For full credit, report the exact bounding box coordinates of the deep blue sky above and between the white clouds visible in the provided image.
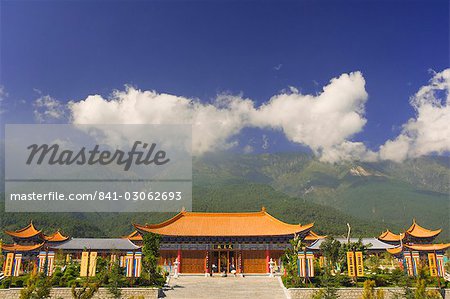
[0,0,449,158]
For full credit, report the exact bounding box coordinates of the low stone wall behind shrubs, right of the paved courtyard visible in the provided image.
[288,288,450,299]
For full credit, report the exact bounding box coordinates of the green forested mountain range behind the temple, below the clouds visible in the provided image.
[0,153,450,240]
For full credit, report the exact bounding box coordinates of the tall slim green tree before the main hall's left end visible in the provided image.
[142,233,165,286]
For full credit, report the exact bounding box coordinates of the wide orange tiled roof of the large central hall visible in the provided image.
[134,208,314,236]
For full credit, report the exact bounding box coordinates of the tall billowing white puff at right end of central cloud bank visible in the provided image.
[254,72,368,162]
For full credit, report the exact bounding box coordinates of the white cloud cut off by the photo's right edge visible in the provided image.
[379,69,450,162]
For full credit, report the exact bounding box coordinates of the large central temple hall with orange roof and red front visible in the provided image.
[134,207,313,274]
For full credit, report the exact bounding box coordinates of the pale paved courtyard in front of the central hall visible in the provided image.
[163,276,286,299]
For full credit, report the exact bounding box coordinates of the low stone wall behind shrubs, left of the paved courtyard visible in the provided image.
[0,288,159,299]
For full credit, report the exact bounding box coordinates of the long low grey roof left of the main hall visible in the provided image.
[51,238,141,250]
